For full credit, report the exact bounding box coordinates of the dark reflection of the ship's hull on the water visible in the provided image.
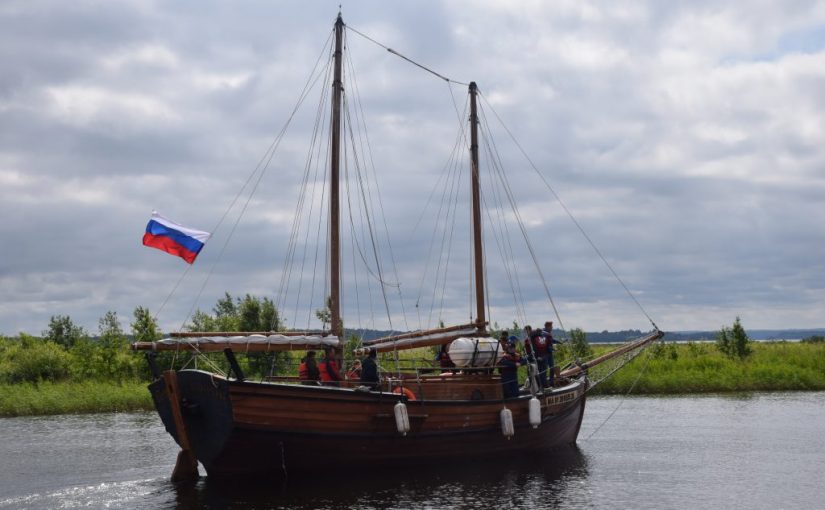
[174,447,587,509]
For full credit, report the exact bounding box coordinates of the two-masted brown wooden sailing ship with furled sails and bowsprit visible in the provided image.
[133,15,662,479]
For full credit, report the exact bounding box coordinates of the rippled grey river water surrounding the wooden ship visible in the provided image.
[0,392,825,510]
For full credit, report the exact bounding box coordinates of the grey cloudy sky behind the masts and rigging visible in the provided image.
[0,0,825,335]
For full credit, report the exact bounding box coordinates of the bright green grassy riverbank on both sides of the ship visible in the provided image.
[0,342,825,417]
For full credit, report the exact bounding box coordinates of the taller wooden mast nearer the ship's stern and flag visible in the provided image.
[329,12,344,338]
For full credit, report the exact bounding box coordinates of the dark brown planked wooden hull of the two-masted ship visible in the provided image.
[150,370,586,477]
